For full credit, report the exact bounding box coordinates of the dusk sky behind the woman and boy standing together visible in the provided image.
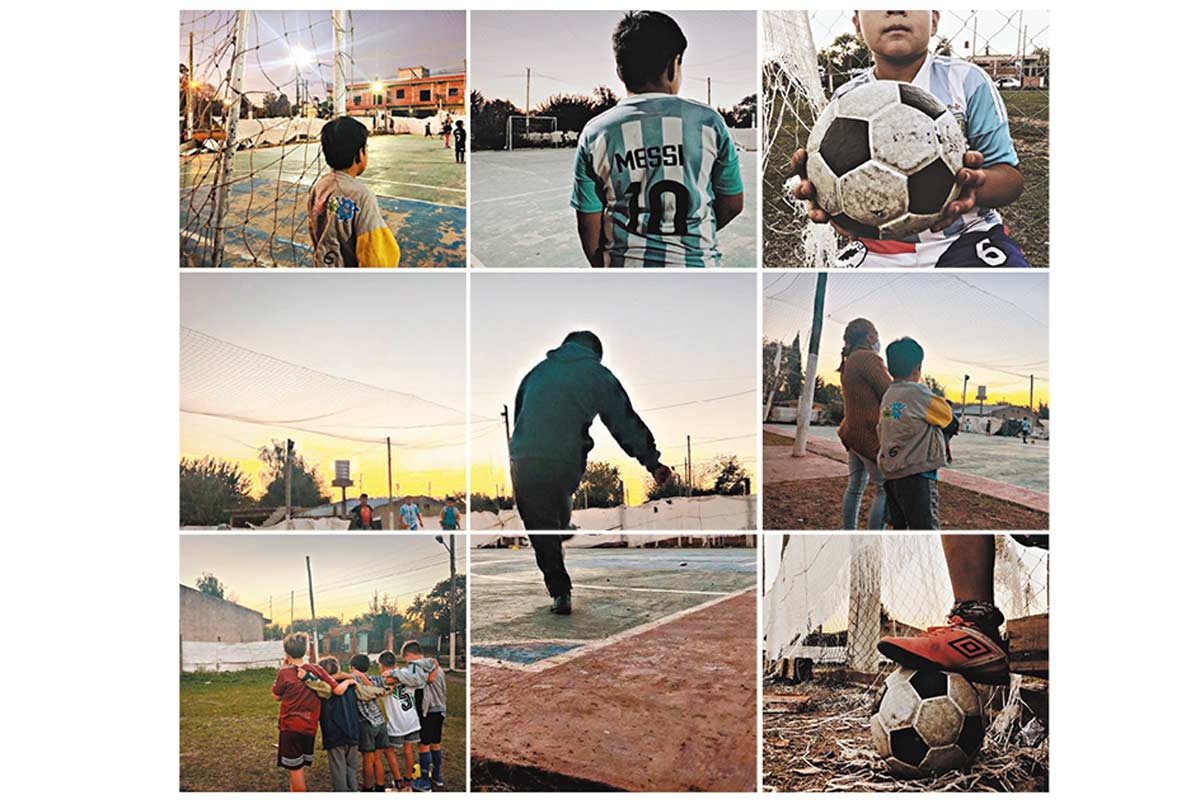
[763,271,1050,405]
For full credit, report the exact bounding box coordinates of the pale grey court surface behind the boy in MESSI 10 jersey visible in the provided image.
[470,148,758,269]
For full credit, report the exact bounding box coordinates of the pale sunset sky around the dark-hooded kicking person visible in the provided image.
[470,271,758,504]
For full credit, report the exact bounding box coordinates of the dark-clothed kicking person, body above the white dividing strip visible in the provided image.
[509,331,671,544]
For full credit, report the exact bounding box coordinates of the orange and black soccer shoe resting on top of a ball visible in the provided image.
[878,603,1008,686]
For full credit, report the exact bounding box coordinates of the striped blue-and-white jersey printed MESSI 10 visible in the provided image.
[571,94,742,267]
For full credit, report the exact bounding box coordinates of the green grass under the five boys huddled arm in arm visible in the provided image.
[179,669,467,792]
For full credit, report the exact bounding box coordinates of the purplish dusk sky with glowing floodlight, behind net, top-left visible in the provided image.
[179,11,467,100]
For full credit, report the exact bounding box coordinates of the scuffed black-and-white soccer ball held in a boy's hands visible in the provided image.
[808,80,967,239]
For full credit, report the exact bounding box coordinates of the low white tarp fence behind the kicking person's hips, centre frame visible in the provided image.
[470,494,758,530]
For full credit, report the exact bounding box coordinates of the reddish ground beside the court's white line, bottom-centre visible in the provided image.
[470,591,757,792]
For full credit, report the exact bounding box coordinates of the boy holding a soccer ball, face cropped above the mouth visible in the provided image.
[792,11,1028,267]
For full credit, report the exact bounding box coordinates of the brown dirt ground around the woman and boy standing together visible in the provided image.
[762,479,1050,530]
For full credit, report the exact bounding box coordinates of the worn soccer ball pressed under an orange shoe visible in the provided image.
[871,669,983,777]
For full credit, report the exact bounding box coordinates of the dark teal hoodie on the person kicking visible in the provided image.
[509,342,659,477]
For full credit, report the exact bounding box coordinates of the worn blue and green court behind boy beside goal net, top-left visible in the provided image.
[179,136,467,267]
